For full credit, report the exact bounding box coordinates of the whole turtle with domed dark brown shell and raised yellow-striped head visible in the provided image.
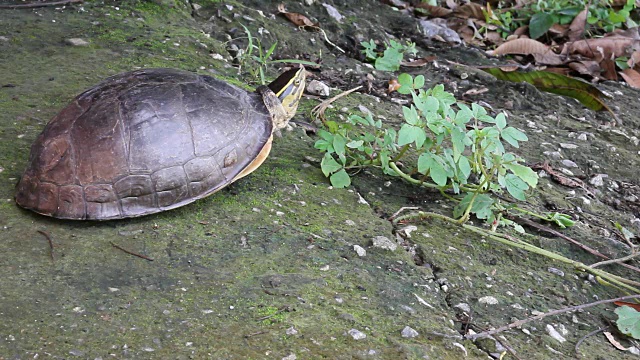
[15,66,306,220]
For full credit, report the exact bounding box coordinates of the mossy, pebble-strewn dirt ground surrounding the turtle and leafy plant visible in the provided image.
[0,0,640,359]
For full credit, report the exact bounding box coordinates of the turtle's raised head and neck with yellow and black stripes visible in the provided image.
[267,65,307,129]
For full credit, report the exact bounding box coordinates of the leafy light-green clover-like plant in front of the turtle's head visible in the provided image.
[315,74,538,222]
